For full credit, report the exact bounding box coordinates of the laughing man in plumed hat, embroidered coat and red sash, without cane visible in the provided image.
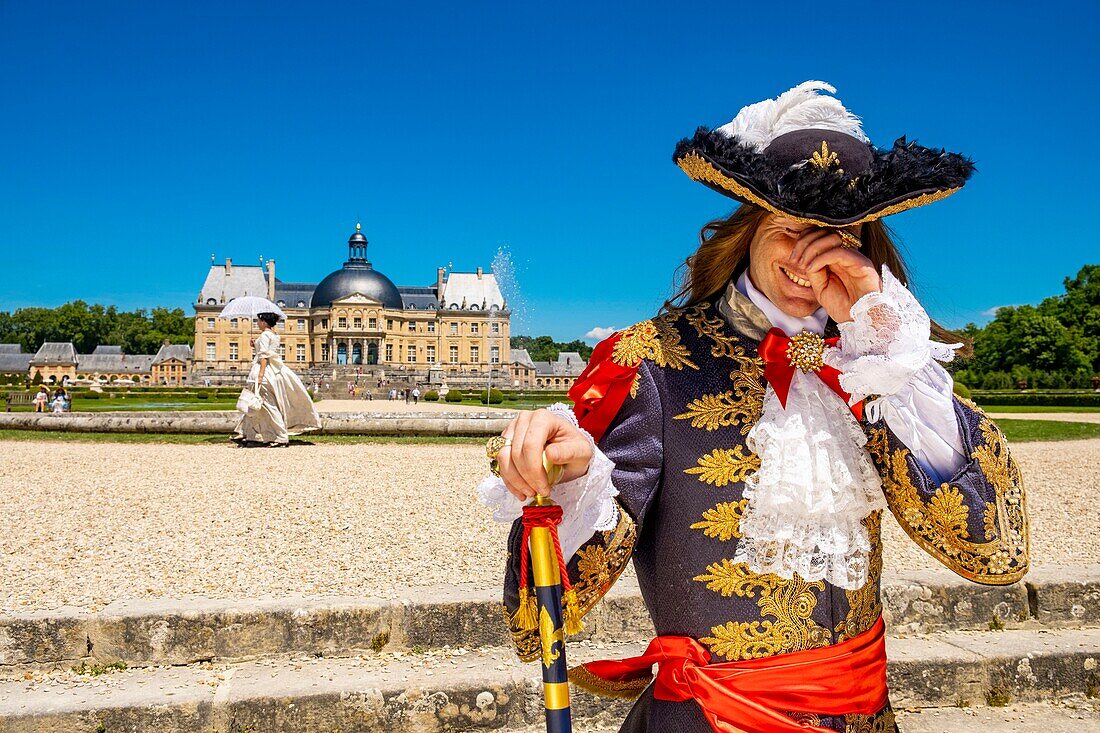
[479,81,1029,733]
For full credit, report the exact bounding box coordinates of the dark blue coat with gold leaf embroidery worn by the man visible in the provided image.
[504,294,1029,733]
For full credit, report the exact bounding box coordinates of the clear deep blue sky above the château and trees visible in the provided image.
[0,0,1100,340]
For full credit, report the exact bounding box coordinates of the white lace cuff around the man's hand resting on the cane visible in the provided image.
[477,402,619,558]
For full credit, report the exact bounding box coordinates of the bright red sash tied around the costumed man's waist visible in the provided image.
[582,616,887,733]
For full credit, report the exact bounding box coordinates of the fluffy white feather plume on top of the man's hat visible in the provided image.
[716,81,869,153]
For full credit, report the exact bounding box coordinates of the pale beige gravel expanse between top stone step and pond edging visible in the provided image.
[0,440,1100,613]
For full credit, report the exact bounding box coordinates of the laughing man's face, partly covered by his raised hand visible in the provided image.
[749,214,858,318]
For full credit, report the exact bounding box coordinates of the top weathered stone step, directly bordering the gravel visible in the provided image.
[0,566,1100,669]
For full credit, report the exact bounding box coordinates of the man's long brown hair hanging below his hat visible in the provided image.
[661,204,970,357]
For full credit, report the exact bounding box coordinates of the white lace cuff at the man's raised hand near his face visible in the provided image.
[825,265,963,407]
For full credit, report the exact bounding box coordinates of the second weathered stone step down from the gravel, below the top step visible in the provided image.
[0,630,1100,733]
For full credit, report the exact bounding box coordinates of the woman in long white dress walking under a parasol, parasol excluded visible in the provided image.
[233,313,321,448]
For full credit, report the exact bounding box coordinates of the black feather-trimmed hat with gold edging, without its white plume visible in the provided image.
[672,128,975,227]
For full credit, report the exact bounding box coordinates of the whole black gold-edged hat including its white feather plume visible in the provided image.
[672,81,974,228]
